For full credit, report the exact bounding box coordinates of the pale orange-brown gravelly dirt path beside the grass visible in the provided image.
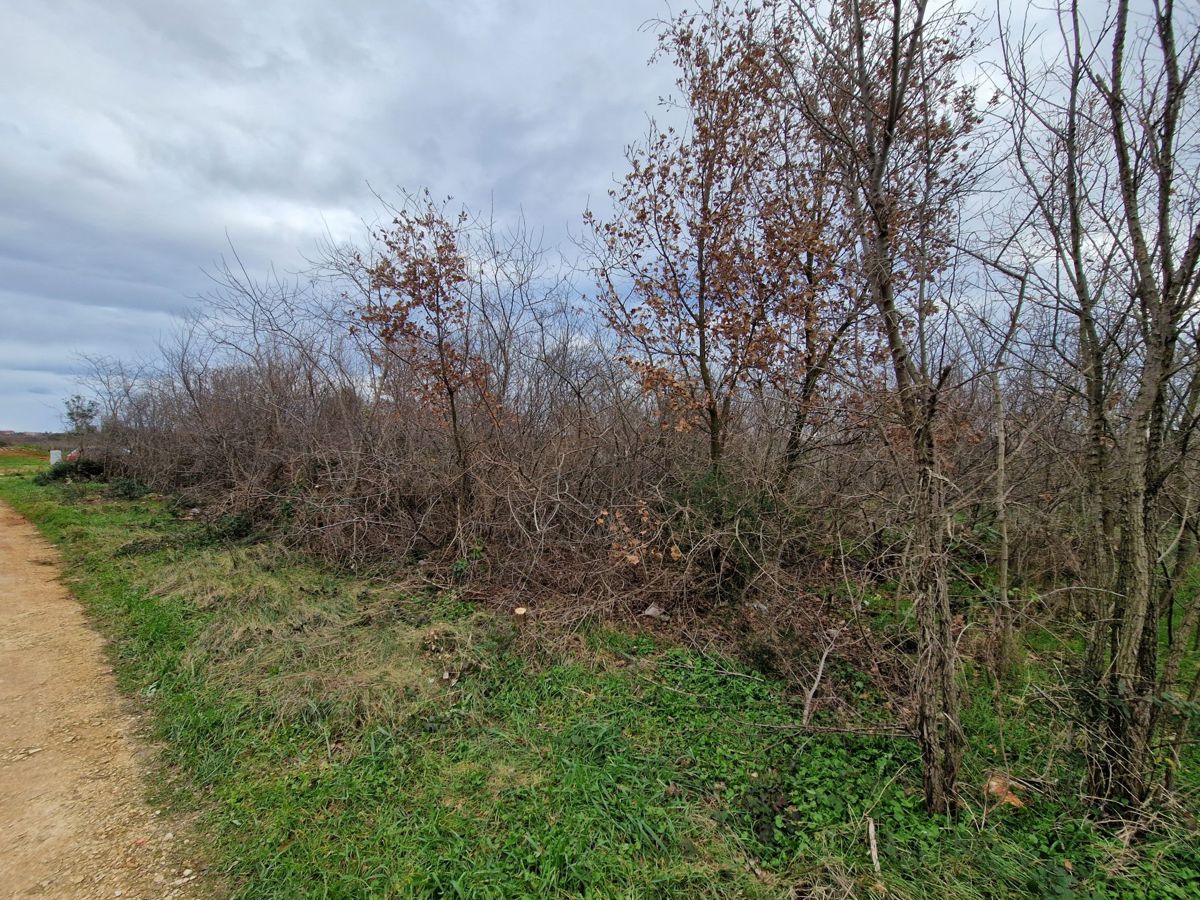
[0,505,206,898]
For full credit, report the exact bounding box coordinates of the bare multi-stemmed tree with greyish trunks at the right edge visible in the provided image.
[1004,0,1200,804]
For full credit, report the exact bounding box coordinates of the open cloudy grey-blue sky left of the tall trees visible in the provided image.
[0,0,673,431]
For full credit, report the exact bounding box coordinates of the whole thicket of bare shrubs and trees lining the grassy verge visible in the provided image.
[87,0,1200,814]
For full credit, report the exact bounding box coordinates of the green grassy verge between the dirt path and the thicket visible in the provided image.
[0,476,1200,898]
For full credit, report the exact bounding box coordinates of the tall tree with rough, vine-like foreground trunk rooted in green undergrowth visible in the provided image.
[770,0,979,812]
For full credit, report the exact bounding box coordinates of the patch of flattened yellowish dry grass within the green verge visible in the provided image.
[146,545,494,733]
